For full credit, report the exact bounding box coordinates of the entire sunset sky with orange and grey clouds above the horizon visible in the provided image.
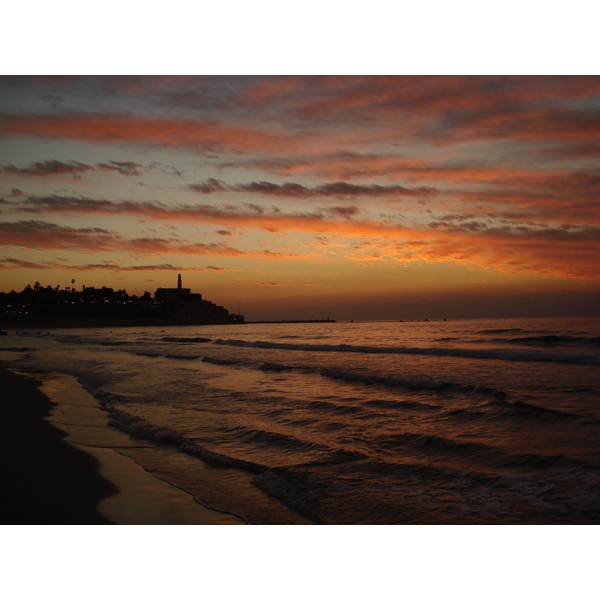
[0,75,600,320]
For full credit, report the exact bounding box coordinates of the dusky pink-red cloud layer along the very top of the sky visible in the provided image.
[0,76,600,158]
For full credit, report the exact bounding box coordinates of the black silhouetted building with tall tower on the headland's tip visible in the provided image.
[154,275,244,325]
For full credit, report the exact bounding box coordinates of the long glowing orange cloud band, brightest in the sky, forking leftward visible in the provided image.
[0,198,600,277]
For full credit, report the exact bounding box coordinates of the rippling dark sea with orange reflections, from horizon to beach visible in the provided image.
[0,318,600,525]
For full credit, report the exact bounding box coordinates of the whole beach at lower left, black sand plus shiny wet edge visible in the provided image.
[0,363,244,525]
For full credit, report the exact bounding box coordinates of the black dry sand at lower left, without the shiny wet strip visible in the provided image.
[0,368,118,525]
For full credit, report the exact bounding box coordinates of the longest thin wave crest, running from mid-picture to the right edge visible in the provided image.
[213,338,600,365]
